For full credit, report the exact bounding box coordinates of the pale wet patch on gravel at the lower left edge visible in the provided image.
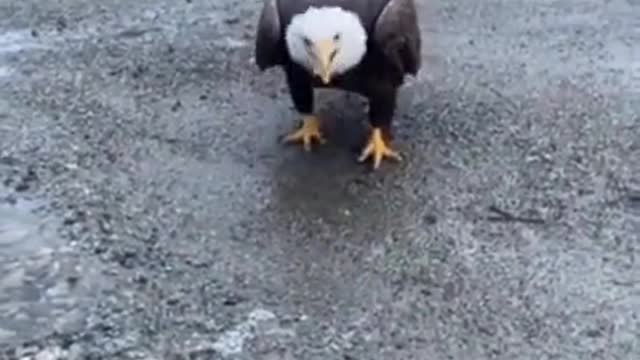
[0,187,108,345]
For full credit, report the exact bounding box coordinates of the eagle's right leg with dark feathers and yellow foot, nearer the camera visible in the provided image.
[358,88,402,169]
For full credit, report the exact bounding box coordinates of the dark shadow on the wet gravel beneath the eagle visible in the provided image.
[272,90,371,217]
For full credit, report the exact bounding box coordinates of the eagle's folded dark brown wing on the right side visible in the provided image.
[373,0,421,75]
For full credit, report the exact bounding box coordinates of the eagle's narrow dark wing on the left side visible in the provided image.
[255,0,284,70]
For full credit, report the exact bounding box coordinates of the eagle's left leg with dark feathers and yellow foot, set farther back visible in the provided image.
[283,66,326,151]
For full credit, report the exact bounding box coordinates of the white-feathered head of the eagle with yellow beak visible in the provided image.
[286,7,367,84]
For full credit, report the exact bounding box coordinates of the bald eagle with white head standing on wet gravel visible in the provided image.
[255,0,421,169]
